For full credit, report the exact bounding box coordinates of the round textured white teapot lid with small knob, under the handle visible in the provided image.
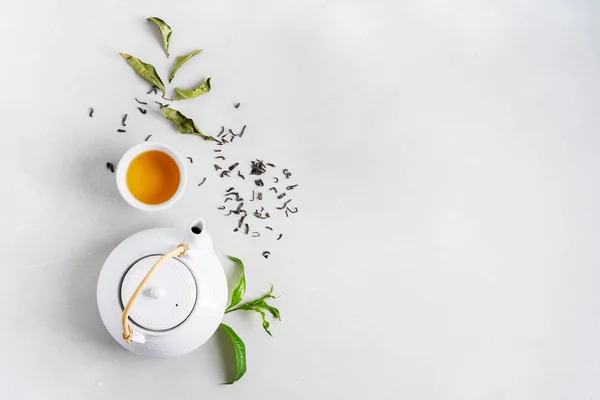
[120,255,197,331]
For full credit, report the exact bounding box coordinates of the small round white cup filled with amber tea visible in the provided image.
[116,142,187,211]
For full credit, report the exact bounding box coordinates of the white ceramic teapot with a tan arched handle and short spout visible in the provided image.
[97,218,227,357]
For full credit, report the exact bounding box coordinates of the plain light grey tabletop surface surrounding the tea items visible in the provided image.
[0,0,600,400]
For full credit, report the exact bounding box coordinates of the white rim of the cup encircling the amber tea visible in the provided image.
[115,142,187,211]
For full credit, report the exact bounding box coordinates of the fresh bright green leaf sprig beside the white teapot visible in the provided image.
[221,256,281,384]
